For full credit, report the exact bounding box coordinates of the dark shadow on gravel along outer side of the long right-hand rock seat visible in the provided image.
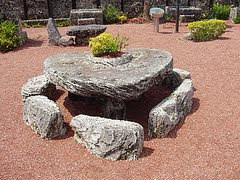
[166,98,200,138]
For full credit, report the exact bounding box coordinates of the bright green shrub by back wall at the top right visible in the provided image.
[211,3,231,20]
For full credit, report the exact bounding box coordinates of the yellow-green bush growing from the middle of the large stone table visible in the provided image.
[89,33,128,56]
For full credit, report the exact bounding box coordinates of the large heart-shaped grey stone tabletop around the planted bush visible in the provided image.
[44,49,173,100]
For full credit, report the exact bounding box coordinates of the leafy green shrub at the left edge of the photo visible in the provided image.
[0,21,24,52]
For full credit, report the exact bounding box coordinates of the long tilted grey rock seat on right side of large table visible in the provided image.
[148,79,194,138]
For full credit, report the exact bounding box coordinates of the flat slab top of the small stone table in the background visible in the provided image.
[67,24,107,37]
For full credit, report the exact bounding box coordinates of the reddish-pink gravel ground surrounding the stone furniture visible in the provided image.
[0,23,240,179]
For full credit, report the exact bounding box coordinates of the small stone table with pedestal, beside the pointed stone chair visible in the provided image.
[67,24,107,46]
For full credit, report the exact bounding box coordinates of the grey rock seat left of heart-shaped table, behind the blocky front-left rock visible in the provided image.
[21,75,56,102]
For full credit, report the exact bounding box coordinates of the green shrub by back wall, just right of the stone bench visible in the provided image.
[103,5,122,24]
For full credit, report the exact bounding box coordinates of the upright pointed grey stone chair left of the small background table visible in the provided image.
[47,18,74,46]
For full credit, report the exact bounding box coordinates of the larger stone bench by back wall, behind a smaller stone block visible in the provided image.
[70,9,103,25]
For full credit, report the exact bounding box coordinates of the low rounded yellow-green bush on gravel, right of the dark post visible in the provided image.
[188,20,226,41]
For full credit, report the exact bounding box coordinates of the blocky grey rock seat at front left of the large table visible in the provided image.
[24,96,66,139]
